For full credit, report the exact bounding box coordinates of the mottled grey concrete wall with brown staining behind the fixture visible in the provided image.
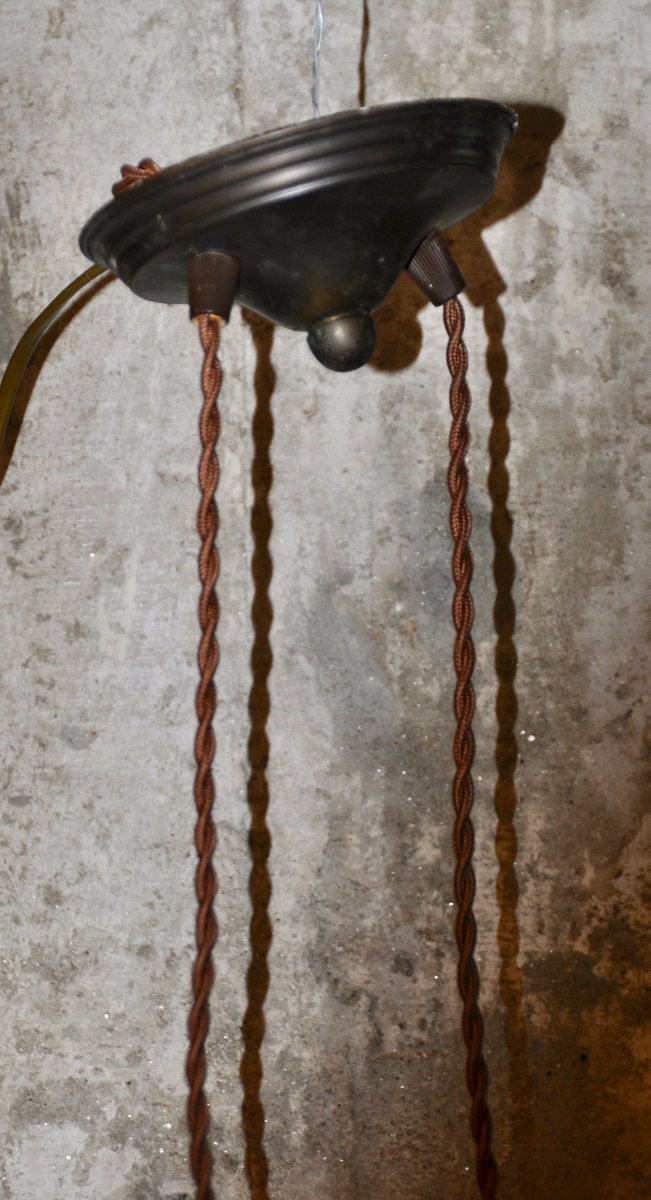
[0,0,651,1200]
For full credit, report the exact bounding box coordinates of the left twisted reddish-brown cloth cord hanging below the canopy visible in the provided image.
[185,316,228,1200]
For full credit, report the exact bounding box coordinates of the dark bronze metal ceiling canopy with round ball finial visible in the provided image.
[79,100,516,370]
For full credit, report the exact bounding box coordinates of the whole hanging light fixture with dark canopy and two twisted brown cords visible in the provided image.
[0,0,516,1200]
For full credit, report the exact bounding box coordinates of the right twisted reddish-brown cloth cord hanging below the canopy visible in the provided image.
[443,292,497,1200]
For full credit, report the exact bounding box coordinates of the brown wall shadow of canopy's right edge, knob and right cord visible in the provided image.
[371,101,565,1200]
